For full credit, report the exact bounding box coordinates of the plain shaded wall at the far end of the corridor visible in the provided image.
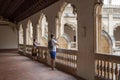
[0,25,18,49]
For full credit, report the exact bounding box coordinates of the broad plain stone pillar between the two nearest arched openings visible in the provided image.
[77,0,95,80]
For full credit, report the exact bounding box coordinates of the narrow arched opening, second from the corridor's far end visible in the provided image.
[26,20,33,45]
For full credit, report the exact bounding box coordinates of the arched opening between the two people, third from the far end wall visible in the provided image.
[37,14,48,46]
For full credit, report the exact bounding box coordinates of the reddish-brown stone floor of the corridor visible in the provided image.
[0,53,77,80]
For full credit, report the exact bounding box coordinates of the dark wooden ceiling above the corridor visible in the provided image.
[0,0,58,22]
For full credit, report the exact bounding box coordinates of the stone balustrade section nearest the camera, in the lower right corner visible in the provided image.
[95,53,120,80]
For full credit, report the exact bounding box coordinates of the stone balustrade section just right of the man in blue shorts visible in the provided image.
[56,49,77,74]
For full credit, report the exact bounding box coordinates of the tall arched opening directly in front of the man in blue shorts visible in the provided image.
[56,3,78,50]
